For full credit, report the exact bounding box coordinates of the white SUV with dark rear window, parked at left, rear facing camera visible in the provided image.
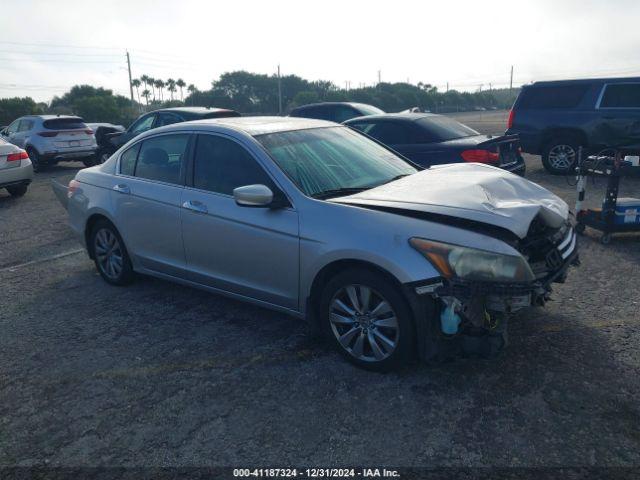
[0,115,98,171]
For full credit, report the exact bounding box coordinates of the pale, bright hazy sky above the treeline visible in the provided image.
[0,0,640,101]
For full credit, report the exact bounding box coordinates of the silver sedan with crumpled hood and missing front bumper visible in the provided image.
[54,117,577,369]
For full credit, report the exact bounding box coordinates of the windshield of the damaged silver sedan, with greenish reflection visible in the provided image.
[256,127,417,198]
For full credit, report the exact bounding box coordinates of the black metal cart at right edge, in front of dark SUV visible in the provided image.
[575,152,640,245]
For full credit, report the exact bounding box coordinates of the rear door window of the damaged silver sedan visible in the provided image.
[134,134,189,184]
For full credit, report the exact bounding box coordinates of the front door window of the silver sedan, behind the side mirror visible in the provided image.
[193,135,274,195]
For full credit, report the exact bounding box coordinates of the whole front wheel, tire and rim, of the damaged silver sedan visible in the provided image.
[319,268,415,371]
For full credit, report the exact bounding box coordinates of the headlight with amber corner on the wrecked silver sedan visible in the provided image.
[409,237,535,282]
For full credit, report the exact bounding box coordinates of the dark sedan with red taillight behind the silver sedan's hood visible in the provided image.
[344,113,525,175]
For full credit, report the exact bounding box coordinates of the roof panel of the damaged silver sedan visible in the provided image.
[142,116,340,137]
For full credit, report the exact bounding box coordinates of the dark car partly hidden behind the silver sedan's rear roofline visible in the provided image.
[96,107,240,163]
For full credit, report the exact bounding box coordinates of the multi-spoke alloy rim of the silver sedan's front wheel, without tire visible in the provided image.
[329,285,400,362]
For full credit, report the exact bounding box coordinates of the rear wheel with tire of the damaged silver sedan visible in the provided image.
[90,220,134,286]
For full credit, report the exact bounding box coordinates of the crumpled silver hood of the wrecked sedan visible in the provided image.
[331,163,569,238]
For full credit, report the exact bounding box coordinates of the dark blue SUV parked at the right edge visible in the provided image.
[506,77,640,174]
